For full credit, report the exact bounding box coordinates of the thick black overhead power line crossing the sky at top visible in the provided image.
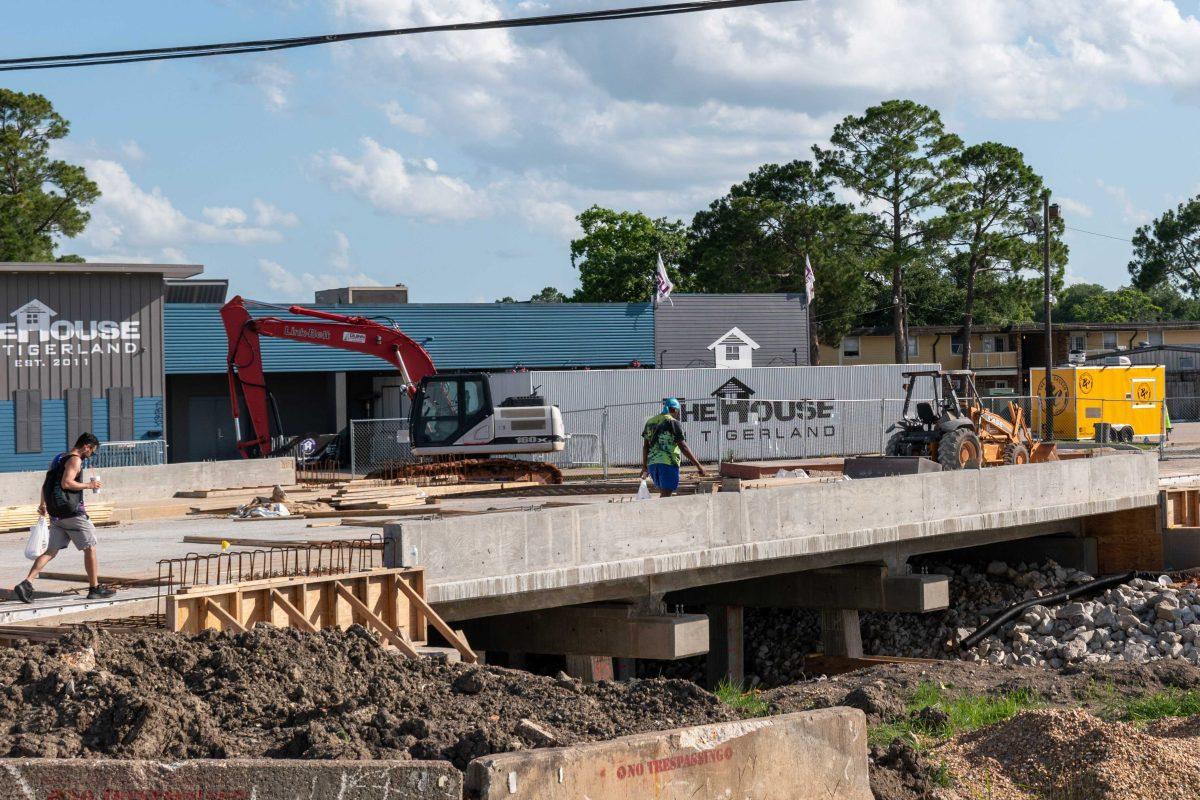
[0,0,799,72]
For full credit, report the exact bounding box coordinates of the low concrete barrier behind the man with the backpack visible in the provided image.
[0,458,296,505]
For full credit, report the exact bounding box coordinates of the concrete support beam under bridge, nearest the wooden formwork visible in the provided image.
[456,604,708,673]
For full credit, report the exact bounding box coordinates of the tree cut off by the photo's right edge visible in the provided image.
[1129,197,1200,297]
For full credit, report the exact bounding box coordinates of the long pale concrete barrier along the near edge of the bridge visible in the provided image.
[385,453,1158,619]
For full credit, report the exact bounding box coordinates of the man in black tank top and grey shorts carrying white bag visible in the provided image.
[13,433,116,603]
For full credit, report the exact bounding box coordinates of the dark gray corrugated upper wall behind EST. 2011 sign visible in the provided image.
[0,273,163,399]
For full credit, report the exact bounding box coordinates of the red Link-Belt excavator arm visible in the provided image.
[221,296,437,458]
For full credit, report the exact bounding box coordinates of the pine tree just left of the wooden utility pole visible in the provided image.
[944,142,1067,369]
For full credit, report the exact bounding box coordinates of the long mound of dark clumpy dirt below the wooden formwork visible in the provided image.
[0,626,737,769]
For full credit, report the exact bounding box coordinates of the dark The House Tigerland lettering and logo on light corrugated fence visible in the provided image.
[679,378,838,443]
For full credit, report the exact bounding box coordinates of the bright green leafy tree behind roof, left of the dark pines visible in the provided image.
[571,205,688,302]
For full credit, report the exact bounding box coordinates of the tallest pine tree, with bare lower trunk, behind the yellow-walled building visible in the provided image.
[812,100,962,363]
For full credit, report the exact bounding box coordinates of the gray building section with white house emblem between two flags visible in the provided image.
[654,294,811,369]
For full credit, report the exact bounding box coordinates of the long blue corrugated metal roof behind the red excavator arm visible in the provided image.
[163,302,654,375]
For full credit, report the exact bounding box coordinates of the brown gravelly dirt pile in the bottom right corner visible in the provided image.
[930,709,1200,800]
